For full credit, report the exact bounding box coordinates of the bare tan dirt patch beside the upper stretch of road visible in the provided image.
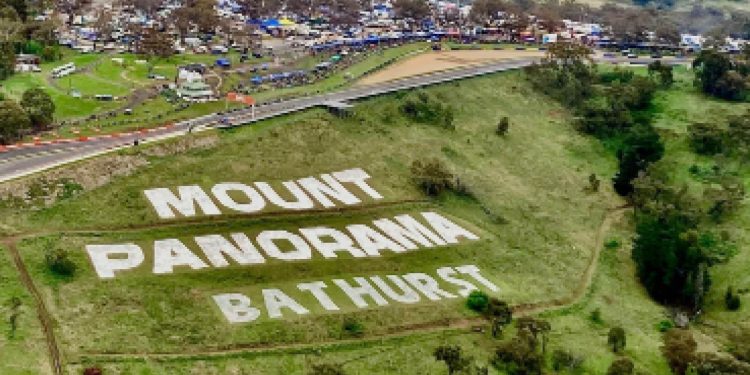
[357,50,544,85]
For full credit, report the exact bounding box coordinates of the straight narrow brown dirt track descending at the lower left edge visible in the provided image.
[2,238,63,375]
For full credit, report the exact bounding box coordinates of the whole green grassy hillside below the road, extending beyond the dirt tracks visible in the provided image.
[0,63,750,375]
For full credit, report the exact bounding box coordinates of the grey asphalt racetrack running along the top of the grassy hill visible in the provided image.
[0,57,688,182]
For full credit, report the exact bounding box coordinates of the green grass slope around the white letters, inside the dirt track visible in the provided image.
[2,72,632,373]
